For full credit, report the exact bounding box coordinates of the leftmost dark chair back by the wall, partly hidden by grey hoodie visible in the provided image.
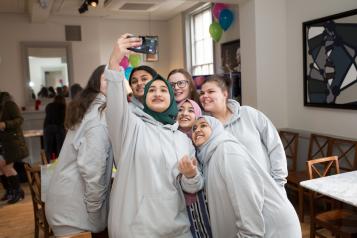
[279,130,299,171]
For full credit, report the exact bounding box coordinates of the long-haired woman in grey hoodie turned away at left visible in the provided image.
[45,65,113,237]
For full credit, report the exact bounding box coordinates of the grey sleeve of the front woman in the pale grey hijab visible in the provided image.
[219,147,265,238]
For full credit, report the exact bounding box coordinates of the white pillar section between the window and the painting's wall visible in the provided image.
[239,0,287,127]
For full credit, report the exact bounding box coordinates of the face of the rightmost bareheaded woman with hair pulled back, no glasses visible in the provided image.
[200,82,228,114]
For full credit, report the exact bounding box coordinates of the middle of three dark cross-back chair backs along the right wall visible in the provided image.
[307,134,331,160]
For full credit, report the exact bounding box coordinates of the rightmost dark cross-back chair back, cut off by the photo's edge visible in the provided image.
[329,138,357,172]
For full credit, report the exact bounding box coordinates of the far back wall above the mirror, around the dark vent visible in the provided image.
[0,14,170,106]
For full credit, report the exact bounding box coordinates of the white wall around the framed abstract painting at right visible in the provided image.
[286,0,357,138]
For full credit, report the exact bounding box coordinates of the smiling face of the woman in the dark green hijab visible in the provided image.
[146,80,170,112]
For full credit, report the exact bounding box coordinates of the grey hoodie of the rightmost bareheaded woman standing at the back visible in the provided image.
[224,99,288,187]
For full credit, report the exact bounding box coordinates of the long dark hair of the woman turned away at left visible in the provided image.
[64,65,106,130]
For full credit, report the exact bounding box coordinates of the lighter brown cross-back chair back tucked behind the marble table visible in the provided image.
[306,156,340,179]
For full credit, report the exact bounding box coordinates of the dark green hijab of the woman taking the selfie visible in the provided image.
[144,74,178,125]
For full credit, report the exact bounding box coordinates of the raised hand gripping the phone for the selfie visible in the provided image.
[109,33,142,71]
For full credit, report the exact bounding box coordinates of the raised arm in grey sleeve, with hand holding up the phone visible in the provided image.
[104,34,141,165]
